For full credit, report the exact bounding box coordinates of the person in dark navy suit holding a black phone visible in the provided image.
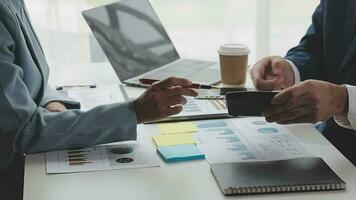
[251,0,356,165]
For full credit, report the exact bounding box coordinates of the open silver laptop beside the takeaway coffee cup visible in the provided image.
[83,0,220,86]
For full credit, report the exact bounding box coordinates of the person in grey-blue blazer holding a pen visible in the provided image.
[0,0,197,200]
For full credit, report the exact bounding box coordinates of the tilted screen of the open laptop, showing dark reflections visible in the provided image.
[83,0,179,82]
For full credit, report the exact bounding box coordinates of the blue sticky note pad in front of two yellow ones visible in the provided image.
[157,144,205,162]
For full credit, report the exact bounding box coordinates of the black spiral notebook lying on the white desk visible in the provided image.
[210,157,346,196]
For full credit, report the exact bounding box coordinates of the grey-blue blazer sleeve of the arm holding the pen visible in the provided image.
[0,18,137,162]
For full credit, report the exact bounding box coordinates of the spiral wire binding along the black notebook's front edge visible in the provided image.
[224,182,346,195]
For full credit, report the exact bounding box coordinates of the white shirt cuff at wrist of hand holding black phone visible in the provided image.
[334,85,356,130]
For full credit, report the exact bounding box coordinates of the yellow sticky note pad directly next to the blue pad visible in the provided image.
[153,134,195,147]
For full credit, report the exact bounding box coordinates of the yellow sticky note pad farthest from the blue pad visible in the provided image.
[158,122,199,134]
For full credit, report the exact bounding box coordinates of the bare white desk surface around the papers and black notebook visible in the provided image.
[24,88,356,200]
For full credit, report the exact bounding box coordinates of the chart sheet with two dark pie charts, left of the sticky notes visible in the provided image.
[46,126,159,174]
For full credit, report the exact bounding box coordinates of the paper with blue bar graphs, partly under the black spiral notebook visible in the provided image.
[196,117,309,163]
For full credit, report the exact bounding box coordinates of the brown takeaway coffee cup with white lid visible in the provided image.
[218,44,250,85]
